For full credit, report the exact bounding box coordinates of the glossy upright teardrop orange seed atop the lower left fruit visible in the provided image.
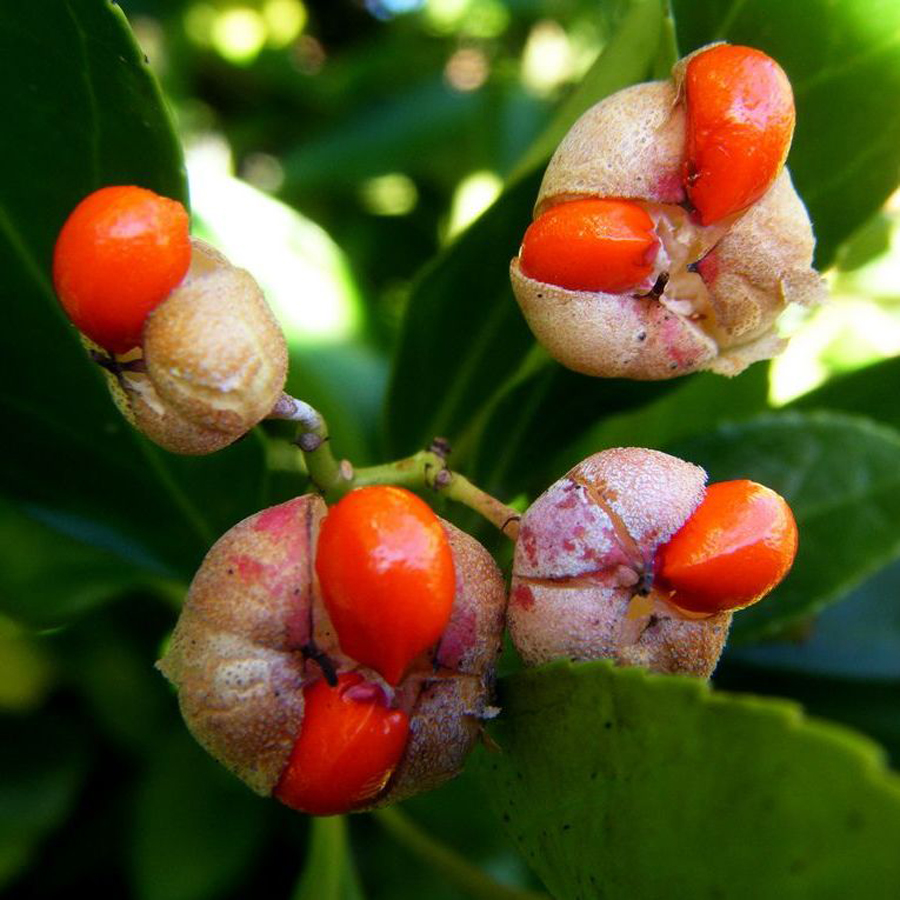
[316,485,456,684]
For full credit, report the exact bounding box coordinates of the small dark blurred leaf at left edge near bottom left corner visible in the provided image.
[0,715,87,887]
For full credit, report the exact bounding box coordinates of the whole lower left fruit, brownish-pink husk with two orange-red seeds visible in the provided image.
[159,486,506,815]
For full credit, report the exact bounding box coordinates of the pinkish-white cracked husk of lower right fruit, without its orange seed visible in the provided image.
[508,448,731,677]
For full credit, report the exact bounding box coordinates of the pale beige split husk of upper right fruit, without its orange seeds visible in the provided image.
[510,45,824,380]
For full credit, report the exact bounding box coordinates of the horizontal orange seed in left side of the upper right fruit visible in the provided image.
[521,199,659,294]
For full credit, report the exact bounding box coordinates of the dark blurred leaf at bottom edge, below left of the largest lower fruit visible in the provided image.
[132,727,267,900]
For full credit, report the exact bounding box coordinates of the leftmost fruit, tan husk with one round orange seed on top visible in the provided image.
[53,186,287,454]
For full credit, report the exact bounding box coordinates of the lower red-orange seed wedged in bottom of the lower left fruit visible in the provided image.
[273,672,409,816]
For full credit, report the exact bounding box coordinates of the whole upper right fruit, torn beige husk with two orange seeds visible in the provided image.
[510,44,823,379]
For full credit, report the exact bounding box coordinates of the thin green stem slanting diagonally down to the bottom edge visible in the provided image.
[372,807,550,900]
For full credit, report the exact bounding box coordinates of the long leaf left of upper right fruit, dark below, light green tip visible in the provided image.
[386,0,668,455]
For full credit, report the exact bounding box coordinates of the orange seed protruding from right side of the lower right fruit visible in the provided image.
[656,481,797,614]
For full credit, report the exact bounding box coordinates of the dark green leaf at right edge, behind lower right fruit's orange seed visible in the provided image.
[667,412,900,641]
